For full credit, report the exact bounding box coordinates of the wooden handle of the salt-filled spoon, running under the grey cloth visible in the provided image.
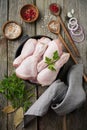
[58,34,87,82]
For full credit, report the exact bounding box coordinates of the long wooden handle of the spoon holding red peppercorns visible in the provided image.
[58,16,79,56]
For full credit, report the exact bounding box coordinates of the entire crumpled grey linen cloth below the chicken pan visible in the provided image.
[24,64,86,127]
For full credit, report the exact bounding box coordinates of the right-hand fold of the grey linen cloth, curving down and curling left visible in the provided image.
[51,64,86,115]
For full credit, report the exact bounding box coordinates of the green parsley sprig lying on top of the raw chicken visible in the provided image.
[45,51,60,71]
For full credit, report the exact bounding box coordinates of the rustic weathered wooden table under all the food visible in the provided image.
[0,0,87,130]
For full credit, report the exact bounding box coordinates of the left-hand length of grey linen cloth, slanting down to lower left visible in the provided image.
[24,80,67,127]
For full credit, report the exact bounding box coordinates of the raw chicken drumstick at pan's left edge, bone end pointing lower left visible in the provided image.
[13,39,37,67]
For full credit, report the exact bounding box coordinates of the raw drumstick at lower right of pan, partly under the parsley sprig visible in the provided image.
[37,53,70,86]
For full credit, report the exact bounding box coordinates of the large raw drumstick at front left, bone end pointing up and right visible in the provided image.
[16,42,47,80]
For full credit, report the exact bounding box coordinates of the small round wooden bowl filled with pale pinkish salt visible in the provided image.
[3,21,22,40]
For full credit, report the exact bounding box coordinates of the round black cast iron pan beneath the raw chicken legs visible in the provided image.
[15,35,72,84]
